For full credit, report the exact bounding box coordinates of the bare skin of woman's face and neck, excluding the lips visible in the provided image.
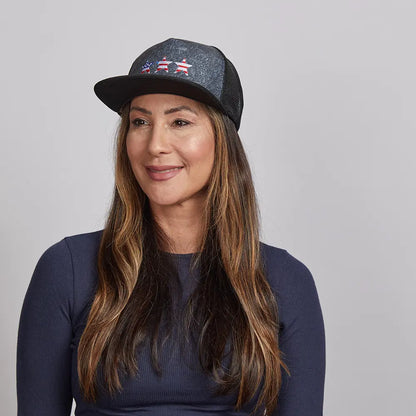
[126,94,215,253]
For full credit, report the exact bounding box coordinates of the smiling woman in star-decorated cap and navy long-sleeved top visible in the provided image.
[17,39,325,416]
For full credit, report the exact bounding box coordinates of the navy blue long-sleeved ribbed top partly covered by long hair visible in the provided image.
[17,230,325,416]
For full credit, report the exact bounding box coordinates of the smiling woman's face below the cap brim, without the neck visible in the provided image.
[126,94,215,209]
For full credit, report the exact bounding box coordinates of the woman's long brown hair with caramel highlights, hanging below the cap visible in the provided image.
[78,100,288,414]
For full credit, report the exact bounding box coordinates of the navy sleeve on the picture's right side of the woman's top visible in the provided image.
[273,252,325,416]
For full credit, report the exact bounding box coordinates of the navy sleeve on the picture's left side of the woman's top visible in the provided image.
[16,239,73,416]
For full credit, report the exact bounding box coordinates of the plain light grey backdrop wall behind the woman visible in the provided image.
[0,0,416,416]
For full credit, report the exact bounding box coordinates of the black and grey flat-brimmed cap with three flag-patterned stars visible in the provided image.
[94,38,243,130]
